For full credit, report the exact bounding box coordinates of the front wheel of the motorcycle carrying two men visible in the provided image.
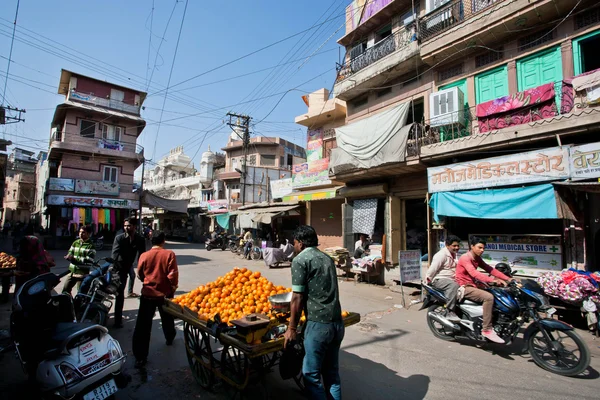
[527,328,590,376]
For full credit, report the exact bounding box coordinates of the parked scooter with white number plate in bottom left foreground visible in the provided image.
[10,271,128,400]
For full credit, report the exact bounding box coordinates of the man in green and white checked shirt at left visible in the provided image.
[63,225,96,294]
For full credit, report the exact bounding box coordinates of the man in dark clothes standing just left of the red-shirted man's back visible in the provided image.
[112,217,146,329]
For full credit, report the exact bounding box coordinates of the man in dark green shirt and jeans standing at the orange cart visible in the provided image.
[284,225,345,400]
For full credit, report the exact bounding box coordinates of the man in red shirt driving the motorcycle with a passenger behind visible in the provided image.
[454,237,512,343]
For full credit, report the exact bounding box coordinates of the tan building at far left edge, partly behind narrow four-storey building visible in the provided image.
[2,147,37,225]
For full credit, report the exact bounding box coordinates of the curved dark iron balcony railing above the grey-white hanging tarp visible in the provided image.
[337,29,417,82]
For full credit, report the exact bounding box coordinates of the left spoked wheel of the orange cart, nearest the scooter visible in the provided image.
[184,323,215,390]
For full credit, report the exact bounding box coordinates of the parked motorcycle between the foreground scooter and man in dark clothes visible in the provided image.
[73,257,121,325]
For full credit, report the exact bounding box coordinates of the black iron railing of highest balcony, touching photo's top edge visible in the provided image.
[420,0,504,41]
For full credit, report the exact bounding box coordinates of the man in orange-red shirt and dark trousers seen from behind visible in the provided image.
[133,232,179,368]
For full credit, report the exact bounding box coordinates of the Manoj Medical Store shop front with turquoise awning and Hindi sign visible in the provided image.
[427,146,585,277]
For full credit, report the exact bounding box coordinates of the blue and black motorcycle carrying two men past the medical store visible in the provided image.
[421,280,590,376]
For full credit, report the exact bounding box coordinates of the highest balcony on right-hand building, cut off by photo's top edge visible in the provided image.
[419,0,584,63]
